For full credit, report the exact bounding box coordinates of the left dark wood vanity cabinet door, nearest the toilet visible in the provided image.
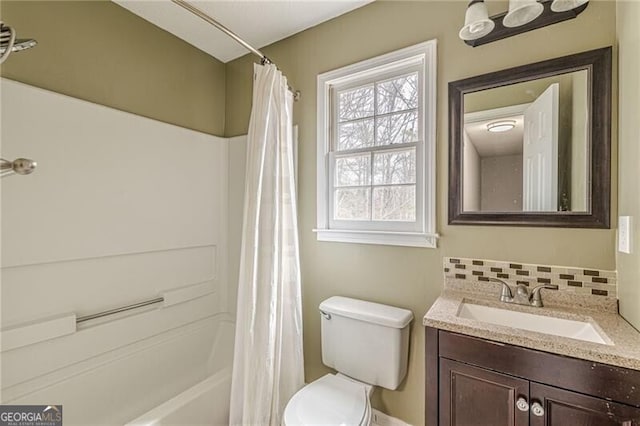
[440,358,529,426]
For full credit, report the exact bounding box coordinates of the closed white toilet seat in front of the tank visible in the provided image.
[283,374,371,426]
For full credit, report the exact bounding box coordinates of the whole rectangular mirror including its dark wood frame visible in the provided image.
[449,48,611,228]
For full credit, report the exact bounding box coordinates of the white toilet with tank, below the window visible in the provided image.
[283,296,413,426]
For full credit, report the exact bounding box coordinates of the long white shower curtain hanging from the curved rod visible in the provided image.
[230,64,304,426]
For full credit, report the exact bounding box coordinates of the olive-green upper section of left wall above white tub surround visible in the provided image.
[0,0,225,136]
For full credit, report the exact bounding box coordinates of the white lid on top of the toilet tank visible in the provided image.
[320,296,413,328]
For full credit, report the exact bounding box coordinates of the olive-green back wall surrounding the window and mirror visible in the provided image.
[225,1,617,425]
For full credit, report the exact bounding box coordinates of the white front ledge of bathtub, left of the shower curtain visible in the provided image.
[125,368,231,426]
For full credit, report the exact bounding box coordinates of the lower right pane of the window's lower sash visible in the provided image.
[373,185,416,222]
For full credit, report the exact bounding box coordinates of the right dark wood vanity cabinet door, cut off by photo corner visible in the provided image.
[530,382,640,426]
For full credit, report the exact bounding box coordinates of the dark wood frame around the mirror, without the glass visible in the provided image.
[449,47,611,228]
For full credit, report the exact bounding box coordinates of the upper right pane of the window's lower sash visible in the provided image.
[373,148,416,185]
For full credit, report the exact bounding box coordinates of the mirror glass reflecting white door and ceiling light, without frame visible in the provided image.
[462,69,590,216]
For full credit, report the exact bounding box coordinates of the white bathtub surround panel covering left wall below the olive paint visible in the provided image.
[0,78,235,426]
